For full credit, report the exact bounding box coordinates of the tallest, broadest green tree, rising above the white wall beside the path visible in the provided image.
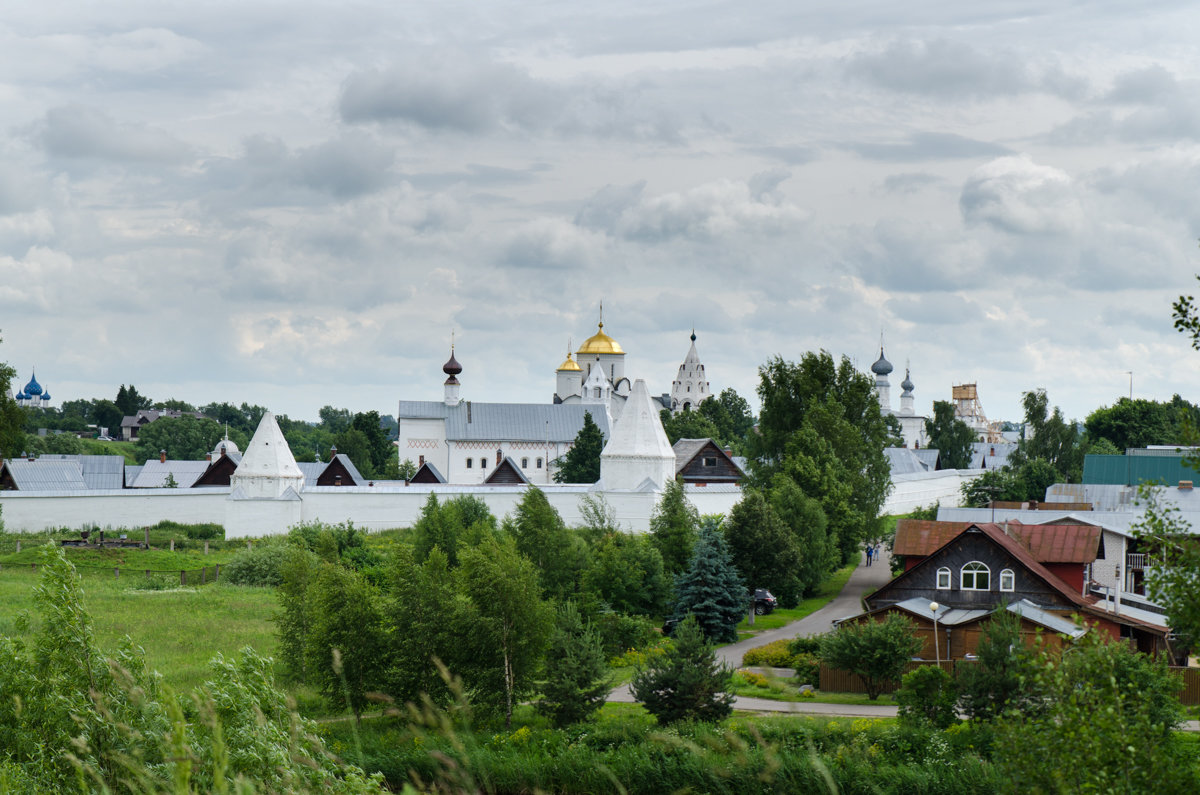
[749,351,892,561]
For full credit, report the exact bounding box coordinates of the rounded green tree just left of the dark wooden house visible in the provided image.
[821,612,920,701]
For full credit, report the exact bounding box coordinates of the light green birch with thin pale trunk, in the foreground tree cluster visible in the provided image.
[456,538,553,728]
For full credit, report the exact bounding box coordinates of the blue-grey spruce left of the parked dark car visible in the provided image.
[674,524,748,644]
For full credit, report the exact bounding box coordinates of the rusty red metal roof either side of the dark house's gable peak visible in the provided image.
[892,519,1100,563]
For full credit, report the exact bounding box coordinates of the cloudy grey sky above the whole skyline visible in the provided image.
[0,0,1200,419]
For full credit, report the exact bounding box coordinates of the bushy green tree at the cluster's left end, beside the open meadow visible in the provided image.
[307,564,388,721]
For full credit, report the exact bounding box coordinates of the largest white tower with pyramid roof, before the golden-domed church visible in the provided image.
[600,378,676,491]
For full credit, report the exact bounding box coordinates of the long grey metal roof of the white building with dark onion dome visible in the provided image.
[396,400,608,442]
